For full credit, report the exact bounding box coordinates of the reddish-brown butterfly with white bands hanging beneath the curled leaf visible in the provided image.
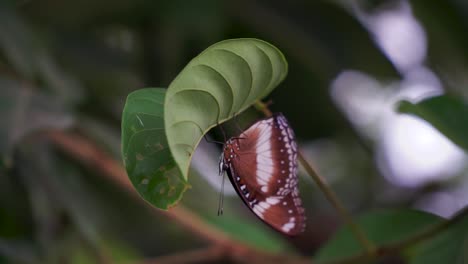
[219,113,306,236]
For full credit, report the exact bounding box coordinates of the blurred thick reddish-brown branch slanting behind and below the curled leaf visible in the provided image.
[45,131,310,263]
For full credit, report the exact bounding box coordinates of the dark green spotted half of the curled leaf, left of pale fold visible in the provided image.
[122,88,189,209]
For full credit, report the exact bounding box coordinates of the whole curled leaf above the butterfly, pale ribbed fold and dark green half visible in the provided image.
[122,39,287,209]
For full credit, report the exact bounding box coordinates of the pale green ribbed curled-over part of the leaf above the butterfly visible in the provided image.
[164,39,288,180]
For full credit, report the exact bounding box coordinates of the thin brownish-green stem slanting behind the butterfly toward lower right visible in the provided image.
[255,101,376,256]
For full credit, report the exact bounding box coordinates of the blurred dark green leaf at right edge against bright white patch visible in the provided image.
[398,95,468,150]
